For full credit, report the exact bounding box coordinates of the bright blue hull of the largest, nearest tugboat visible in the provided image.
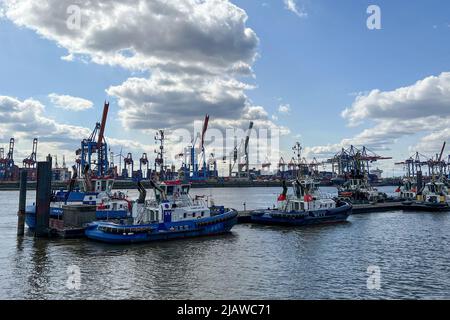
[85,211,237,244]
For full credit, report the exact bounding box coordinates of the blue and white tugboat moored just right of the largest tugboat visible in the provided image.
[251,178,352,226]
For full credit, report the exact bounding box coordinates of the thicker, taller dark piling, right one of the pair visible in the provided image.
[35,158,52,237]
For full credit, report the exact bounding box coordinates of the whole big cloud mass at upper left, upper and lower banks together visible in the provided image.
[1,0,278,136]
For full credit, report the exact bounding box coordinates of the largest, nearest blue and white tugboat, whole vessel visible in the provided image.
[85,180,238,244]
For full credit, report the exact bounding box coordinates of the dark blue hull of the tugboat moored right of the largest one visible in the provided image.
[251,204,352,226]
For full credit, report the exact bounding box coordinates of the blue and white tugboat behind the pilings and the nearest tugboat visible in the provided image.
[25,167,132,230]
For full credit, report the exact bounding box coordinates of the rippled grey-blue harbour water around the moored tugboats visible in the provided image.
[0,188,450,299]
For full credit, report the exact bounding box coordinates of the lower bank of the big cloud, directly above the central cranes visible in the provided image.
[107,72,253,129]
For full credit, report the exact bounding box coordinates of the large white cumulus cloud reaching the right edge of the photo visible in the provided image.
[308,72,450,160]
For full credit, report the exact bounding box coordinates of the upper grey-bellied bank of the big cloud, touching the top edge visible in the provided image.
[1,0,258,72]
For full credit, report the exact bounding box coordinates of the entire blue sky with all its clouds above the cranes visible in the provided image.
[0,0,450,176]
